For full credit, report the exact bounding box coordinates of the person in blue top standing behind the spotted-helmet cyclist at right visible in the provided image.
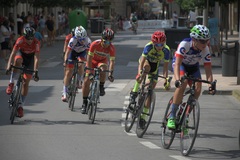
[208,12,220,57]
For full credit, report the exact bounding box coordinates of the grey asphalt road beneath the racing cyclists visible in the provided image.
[0,31,240,160]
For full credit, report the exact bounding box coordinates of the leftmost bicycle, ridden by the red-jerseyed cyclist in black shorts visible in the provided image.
[8,65,34,124]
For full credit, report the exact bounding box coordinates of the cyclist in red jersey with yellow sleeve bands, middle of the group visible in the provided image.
[82,28,115,114]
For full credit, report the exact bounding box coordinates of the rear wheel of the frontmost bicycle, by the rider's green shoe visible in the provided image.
[161,97,175,149]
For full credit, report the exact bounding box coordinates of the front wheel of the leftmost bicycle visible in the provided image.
[10,82,22,124]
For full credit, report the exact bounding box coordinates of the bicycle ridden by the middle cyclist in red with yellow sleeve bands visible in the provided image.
[85,67,111,124]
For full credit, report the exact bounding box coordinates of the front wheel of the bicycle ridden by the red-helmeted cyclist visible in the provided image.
[136,91,156,138]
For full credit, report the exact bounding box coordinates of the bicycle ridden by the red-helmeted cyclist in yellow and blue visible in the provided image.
[125,73,172,138]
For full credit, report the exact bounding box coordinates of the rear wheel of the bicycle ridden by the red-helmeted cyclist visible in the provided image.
[124,102,137,132]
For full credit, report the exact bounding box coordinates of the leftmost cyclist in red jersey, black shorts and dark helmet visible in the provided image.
[6,27,40,118]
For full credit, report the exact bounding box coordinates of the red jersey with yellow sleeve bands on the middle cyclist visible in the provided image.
[88,39,115,62]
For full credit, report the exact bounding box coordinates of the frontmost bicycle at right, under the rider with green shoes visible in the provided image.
[161,76,217,156]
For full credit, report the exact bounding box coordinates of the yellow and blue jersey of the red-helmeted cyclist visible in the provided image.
[142,41,170,63]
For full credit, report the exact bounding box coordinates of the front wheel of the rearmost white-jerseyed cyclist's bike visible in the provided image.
[68,74,78,111]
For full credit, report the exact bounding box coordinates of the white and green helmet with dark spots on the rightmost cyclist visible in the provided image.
[190,25,211,40]
